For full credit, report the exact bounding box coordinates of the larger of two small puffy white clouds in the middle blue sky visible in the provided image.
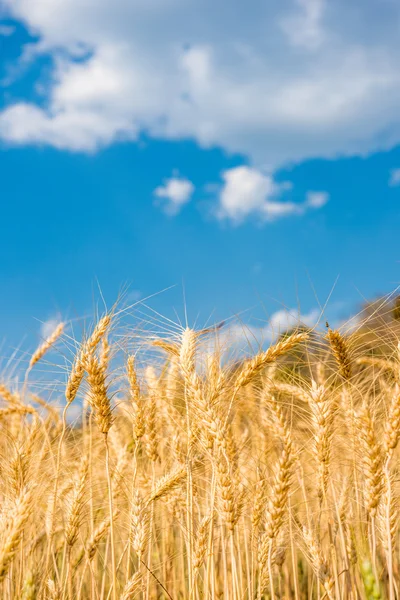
[217,165,329,224]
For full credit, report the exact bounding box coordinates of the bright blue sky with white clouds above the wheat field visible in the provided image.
[0,0,400,344]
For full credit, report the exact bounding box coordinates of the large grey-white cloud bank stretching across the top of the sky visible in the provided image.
[0,0,400,169]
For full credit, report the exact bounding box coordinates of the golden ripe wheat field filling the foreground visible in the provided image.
[0,312,400,600]
